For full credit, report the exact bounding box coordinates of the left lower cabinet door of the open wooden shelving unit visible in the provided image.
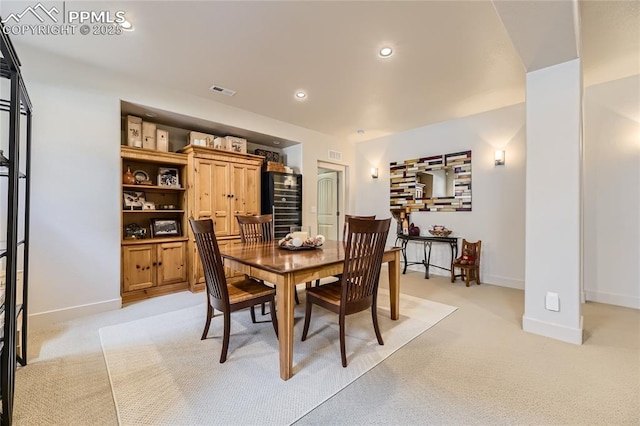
[122,244,156,292]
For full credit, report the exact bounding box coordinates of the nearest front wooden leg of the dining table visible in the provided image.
[276,275,295,380]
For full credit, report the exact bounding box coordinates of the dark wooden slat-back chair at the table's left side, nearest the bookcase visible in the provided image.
[189,219,278,363]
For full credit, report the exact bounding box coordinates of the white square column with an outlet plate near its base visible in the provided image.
[522,59,582,344]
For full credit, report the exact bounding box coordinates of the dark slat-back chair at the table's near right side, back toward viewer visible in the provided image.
[302,218,391,367]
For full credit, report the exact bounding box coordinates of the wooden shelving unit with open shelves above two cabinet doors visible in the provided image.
[120,146,188,303]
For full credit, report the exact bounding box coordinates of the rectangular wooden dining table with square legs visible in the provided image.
[220,241,400,380]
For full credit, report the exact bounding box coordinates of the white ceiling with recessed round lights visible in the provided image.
[0,0,640,142]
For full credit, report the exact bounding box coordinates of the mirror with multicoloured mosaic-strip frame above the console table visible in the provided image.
[389,151,471,213]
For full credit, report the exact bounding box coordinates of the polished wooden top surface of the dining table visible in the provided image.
[220,240,400,274]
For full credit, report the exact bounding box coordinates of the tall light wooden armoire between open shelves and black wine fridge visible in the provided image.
[180,145,263,291]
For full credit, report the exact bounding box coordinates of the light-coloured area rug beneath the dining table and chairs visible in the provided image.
[100,290,456,425]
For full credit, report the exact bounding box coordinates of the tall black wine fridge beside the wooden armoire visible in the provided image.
[262,172,302,238]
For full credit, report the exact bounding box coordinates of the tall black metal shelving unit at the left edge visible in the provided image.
[0,24,32,425]
